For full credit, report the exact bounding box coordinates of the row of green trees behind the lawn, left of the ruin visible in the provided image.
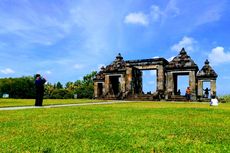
[0,71,97,99]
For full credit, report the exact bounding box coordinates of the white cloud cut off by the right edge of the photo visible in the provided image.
[208,46,230,65]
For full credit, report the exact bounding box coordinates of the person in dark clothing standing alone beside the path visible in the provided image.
[35,74,46,106]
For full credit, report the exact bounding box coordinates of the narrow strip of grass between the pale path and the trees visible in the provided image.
[0,98,109,107]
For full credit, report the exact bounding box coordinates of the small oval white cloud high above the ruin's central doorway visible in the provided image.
[124,12,149,26]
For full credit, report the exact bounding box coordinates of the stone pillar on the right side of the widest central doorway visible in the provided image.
[156,65,165,91]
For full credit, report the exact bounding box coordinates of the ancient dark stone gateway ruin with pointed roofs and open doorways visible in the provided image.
[94,48,217,100]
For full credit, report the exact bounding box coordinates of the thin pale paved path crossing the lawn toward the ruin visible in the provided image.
[0,101,135,111]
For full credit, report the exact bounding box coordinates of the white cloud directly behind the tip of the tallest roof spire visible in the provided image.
[171,36,197,52]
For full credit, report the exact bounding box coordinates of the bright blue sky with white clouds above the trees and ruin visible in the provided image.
[0,0,230,94]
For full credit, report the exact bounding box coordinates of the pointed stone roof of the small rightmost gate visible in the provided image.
[197,59,218,79]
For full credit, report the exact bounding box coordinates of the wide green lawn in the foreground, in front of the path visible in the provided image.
[0,102,230,153]
